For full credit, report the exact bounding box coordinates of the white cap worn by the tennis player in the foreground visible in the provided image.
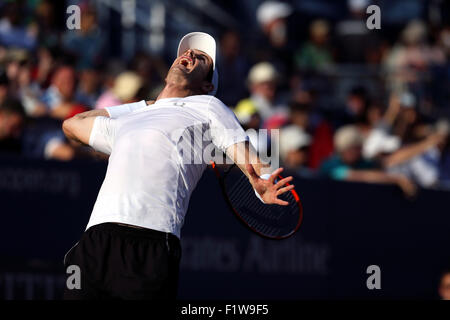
[177,32,219,96]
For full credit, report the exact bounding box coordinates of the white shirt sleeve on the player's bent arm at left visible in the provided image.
[89,117,116,154]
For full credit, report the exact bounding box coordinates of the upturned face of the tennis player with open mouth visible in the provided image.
[166,49,213,94]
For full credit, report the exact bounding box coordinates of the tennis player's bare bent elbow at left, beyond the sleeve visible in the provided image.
[63,109,109,145]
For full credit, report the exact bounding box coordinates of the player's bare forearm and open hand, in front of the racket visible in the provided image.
[226,141,294,205]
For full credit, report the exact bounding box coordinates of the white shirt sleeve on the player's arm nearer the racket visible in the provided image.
[208,97,248,152]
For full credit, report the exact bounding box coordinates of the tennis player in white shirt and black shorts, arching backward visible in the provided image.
[63,32,293,299]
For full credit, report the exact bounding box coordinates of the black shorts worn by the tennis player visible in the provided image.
[64,223,181,300]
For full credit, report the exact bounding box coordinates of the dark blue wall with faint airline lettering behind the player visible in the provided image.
[0,159,450,299]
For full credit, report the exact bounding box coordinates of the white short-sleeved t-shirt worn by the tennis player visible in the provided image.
[86,95,248,237]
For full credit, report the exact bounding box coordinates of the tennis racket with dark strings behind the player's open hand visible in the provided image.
[211,163,303,239]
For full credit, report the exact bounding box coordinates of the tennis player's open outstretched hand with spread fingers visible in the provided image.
[245,164,294,206]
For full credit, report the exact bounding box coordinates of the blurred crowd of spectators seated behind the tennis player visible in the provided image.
[0,0,450,192]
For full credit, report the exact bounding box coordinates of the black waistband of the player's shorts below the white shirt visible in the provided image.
[86,222,179,241]
